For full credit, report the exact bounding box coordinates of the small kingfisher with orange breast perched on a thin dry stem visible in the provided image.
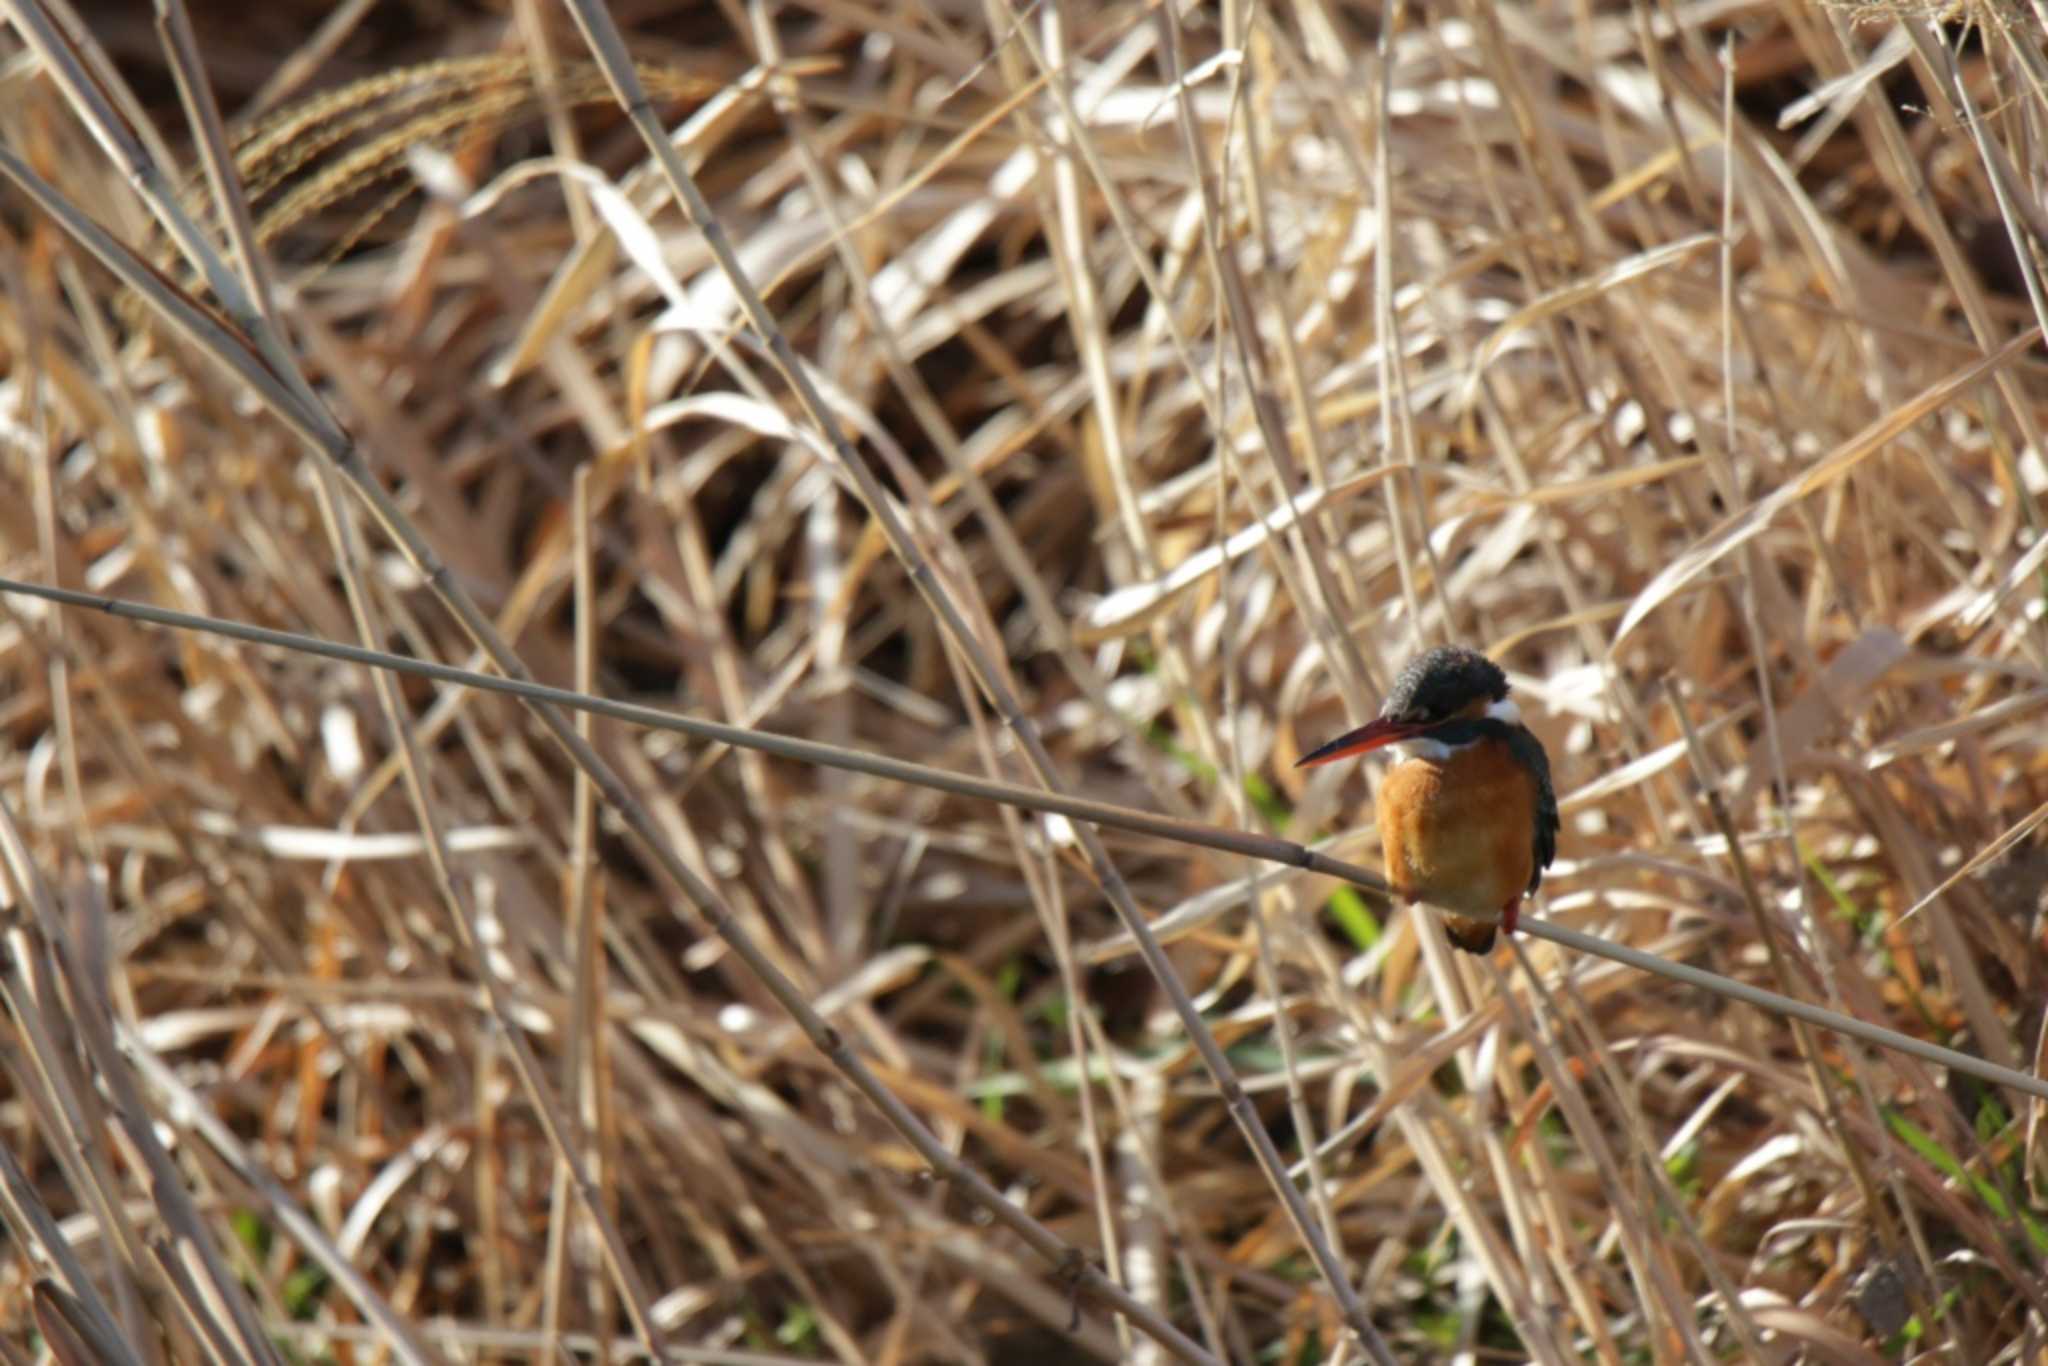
[1296,645,1559,954]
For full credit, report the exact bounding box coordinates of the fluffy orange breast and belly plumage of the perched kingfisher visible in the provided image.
[1378,739,1536,913]
